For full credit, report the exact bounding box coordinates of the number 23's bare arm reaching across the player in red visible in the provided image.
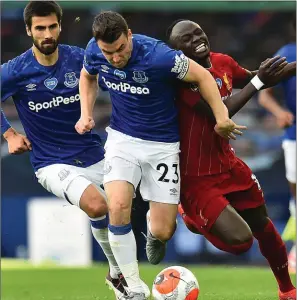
[183,59,246,139]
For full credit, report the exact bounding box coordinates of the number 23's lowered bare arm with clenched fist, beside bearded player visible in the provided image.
[75,68,98,134]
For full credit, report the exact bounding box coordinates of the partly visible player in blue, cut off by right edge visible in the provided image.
[259,15,296,273]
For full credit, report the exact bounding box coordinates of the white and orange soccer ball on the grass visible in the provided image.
[152,266,199,300]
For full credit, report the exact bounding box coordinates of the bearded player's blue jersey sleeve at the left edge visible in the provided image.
[1,61,18,102]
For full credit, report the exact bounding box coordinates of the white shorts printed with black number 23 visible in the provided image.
[104,127,180,204]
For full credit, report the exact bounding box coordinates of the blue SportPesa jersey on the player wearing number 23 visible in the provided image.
[84,34,189,143]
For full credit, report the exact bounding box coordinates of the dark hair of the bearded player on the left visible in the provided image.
[24,1,63,29]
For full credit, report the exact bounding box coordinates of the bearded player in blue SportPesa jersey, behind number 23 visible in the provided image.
[1,1,146,297]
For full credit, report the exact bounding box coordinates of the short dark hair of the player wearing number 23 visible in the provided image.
[92,11,128,44]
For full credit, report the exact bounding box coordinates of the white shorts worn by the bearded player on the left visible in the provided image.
[35,160,106,207]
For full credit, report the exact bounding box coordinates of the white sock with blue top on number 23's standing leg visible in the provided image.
[108,224,144,293]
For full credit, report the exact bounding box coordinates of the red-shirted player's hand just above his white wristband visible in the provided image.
[258,55,288,85]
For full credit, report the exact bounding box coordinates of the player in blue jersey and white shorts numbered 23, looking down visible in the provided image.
[76,11,245,300]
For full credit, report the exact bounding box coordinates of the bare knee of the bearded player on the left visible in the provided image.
[84,193,108,218]
